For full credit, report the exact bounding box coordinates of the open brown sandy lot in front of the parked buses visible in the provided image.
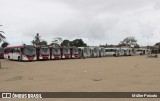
[0,56,160,101]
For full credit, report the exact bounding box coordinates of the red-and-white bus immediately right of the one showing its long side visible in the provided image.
[36,46,50,60]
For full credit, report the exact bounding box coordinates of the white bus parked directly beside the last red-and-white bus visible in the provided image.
[78,47,91,58]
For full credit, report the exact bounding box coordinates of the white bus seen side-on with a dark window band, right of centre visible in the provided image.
[105,48,120,57]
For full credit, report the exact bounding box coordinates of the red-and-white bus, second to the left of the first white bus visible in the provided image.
[60,47,71,59]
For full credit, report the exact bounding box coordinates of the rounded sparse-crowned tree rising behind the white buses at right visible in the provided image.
[119,37,139,47]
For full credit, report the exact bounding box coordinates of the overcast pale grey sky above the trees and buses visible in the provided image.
[0,0,160,46]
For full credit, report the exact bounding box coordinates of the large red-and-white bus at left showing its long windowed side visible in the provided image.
[4,45,36,61]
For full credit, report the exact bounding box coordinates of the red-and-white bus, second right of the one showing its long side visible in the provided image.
[50,47,61,60]
